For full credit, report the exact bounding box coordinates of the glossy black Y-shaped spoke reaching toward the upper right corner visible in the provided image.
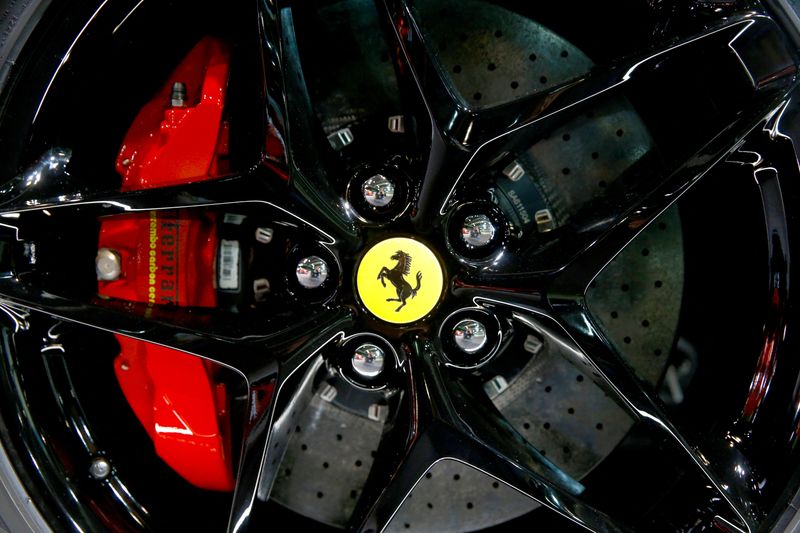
[384,8,796,229]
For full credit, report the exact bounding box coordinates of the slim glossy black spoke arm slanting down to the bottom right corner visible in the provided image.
[516,300,762,530]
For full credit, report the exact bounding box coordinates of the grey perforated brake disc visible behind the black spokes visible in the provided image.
[273,1,683,531]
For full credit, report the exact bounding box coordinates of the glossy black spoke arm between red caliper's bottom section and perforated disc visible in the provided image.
[228,312,352,532]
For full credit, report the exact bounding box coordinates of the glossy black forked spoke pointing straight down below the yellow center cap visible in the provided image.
[351,334,624,531]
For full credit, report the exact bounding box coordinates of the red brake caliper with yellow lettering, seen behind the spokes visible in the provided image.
[98,37,238,490]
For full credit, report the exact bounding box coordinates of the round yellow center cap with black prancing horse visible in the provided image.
[356,237,444,324]
